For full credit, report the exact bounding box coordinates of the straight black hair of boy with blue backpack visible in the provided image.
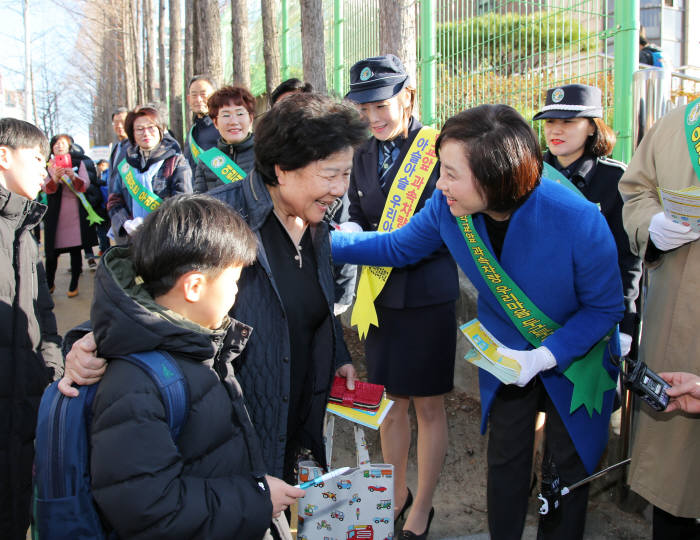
[130,194,257,298]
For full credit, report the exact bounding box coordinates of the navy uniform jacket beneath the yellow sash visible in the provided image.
[348,118,459,309]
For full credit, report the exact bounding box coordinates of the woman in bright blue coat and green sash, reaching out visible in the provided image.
[333,105,624,539]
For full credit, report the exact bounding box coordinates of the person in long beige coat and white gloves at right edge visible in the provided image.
[619,102,700,540]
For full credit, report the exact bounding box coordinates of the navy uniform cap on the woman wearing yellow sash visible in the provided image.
[345,54,409,103]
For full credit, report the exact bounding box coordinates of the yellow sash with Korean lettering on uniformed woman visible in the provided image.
[350,127,438,339]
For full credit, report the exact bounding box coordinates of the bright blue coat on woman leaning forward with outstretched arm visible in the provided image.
[332,179,624,472]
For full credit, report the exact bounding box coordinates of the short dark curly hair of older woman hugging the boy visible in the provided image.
[255,93,368,186]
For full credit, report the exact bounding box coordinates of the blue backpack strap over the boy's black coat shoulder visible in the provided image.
[119,351,190,442]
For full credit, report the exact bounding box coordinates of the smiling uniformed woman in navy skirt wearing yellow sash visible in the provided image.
[341,54,459,538]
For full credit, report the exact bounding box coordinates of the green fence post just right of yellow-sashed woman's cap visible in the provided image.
[420,0,437,126]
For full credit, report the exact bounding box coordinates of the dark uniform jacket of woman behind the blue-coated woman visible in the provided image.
[544,152,642,335]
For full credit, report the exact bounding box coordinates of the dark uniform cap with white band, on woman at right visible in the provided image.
[532,84,603,120]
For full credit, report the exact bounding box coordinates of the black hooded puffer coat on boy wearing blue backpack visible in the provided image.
[91,247,272,540]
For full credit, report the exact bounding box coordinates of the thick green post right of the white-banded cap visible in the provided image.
[613,0,639,163]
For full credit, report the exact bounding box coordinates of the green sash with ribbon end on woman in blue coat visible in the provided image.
[456,216,615,417]
